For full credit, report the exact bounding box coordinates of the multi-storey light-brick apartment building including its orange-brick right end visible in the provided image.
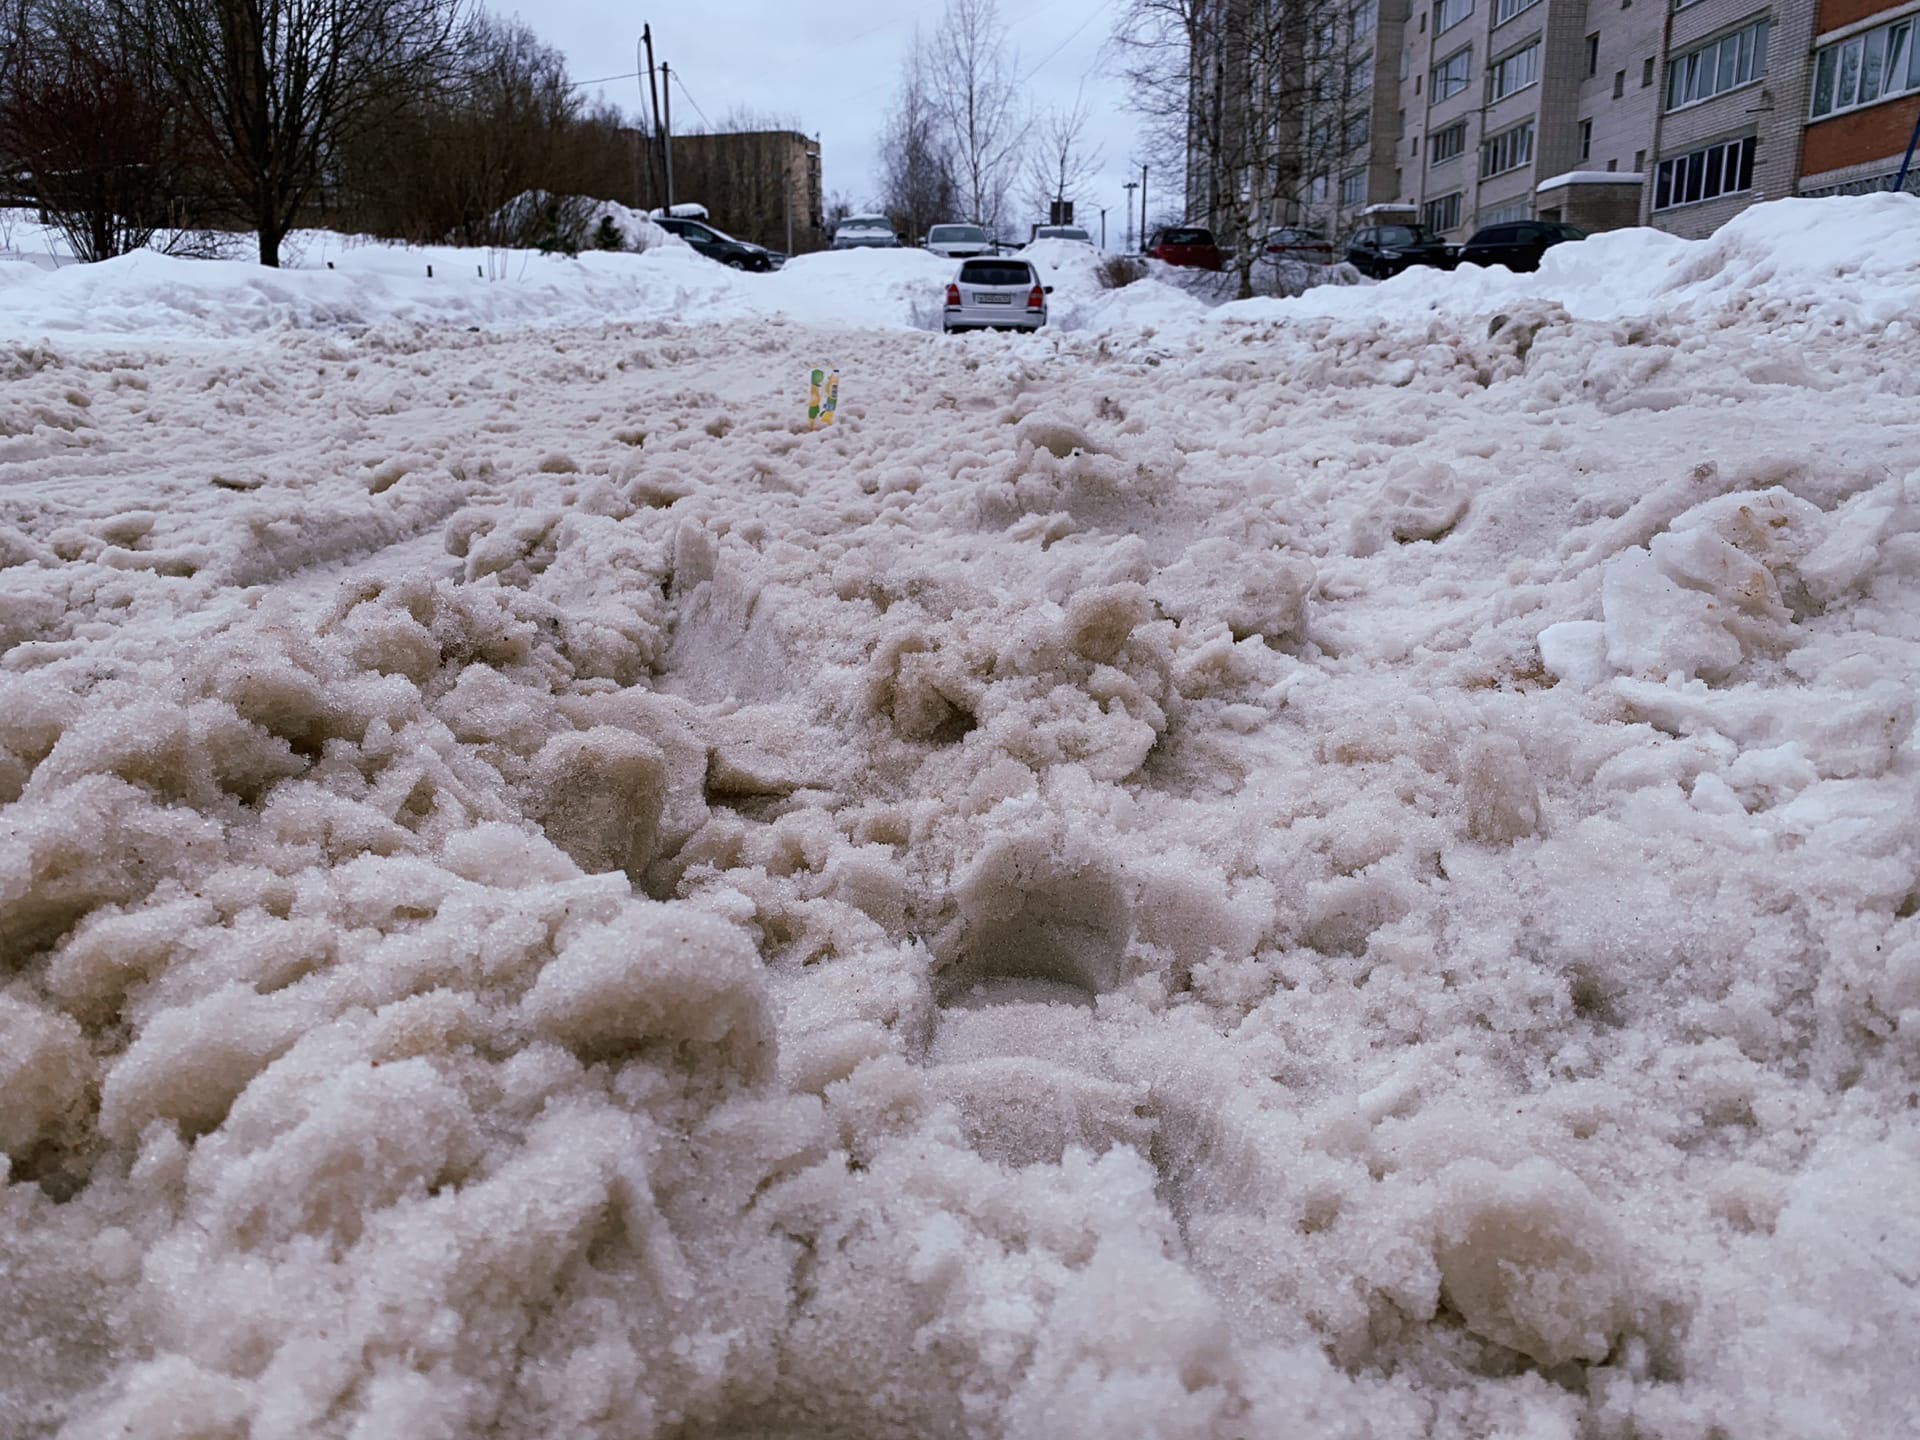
[1190,0,1920,240]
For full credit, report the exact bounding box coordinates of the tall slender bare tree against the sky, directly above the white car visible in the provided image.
[927,0,1027,230]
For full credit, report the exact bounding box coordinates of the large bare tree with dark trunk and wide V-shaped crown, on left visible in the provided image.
[124,0,465,265]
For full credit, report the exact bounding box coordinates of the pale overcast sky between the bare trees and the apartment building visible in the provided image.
[537,0,1171,248]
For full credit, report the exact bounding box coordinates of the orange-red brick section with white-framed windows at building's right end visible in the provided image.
[1799,0,1920,196]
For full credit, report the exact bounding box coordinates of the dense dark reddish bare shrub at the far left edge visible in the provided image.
[0,0,194,261]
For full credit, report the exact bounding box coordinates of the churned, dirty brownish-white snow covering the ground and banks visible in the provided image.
[11,196,1920,1440]
